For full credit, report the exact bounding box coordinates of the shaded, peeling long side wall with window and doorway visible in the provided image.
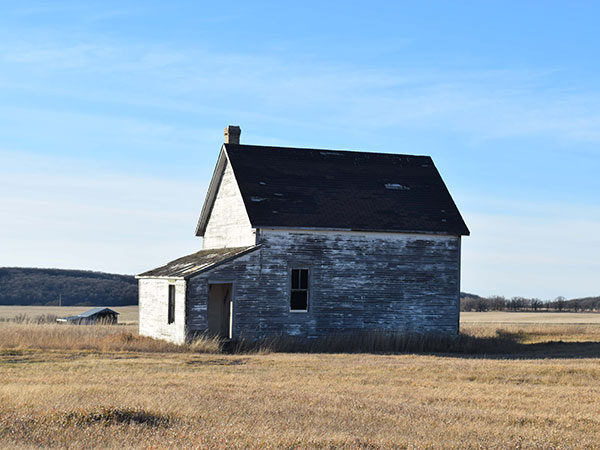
[187,230,460,337]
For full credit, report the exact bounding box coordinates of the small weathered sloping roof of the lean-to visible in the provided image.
[137,245,259,278]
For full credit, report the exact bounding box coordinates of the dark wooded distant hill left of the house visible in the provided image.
[0,267,138,306]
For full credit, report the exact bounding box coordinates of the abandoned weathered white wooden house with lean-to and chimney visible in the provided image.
[138,126,469,342]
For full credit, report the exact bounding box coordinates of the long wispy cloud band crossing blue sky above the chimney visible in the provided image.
[0,37,600,143]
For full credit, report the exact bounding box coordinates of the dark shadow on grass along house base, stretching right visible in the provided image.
[222,330,600,359]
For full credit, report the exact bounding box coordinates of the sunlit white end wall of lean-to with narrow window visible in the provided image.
[138,278,186,343]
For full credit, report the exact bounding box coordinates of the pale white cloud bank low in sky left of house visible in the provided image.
[0,151,206,273]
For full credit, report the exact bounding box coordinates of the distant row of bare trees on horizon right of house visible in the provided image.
[460,293,600,312]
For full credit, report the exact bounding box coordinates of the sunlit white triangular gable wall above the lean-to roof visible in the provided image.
[203,161,256,249]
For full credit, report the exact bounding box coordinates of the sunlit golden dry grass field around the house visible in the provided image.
[0,312,600,449]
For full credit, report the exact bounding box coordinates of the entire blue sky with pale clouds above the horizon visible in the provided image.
[0,1,600,299]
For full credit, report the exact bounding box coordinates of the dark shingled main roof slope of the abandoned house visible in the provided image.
[225,144,469,235]
